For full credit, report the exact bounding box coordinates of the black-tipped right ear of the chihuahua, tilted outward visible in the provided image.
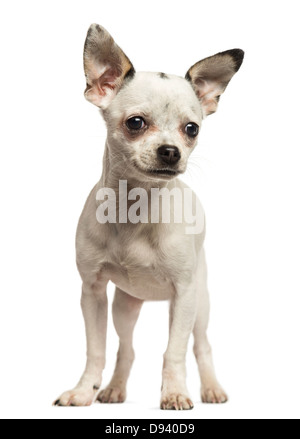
[186,49,244,116]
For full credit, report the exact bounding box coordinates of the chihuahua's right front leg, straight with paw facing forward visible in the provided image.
[161,283,197,410]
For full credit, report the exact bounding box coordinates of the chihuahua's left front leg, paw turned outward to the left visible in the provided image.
[54,283,107,406]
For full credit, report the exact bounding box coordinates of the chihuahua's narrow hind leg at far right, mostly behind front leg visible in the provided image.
[193,250,228,404]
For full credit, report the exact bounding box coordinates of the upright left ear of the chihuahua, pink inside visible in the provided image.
[84,24,134,110]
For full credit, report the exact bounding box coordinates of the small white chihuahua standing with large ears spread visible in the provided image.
[54,24,244,410]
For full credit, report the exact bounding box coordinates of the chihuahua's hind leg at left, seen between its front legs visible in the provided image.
[98,288,143,403]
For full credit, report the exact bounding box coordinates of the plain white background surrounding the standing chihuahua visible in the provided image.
[0,0,300,419]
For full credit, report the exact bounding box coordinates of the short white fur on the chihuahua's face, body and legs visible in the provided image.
[56,24,236,409]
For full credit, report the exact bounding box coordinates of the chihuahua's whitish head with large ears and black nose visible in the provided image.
[84,24,244,181]
